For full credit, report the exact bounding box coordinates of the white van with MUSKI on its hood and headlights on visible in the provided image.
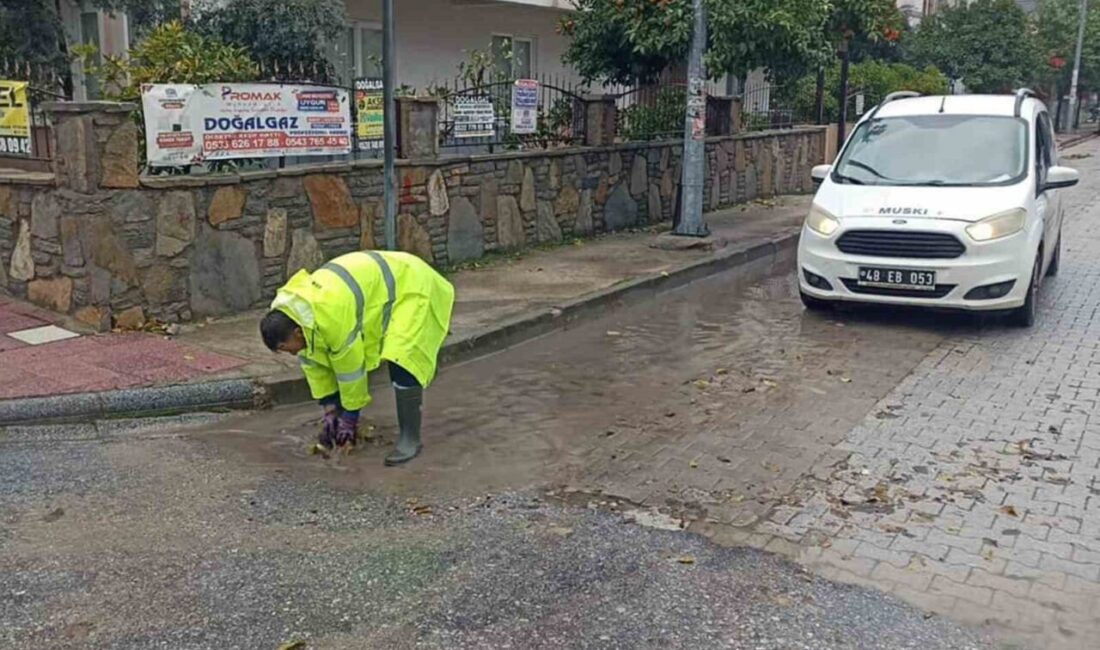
[799,89,1078,327]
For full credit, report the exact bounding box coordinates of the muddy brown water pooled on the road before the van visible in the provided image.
[198,251,978,526]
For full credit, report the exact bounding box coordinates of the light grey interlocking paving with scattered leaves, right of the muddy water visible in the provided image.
[754,131,1100,648]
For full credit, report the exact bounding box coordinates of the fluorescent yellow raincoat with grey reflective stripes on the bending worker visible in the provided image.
[272,251,454,410]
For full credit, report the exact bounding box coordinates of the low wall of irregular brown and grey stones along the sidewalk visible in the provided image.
[0,101,825,328]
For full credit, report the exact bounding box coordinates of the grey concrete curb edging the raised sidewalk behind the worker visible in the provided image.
[0,228,799,427]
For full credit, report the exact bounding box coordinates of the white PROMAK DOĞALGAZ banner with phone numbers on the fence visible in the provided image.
[142,84,351,166]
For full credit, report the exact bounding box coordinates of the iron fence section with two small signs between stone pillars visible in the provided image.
[431,76,587,155]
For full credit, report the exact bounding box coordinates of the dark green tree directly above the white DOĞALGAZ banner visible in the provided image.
[195,0,345,79]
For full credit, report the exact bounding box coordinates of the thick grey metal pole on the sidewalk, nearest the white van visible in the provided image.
[672,0,710,236]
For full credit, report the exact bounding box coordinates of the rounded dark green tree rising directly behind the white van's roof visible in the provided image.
[910,0,1040,92]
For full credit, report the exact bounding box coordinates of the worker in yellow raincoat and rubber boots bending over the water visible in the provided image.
[260,251,454,465]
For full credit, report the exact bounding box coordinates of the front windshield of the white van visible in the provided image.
[833,114,1027,187]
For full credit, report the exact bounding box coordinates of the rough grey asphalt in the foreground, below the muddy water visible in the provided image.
[0,420,986,649]
